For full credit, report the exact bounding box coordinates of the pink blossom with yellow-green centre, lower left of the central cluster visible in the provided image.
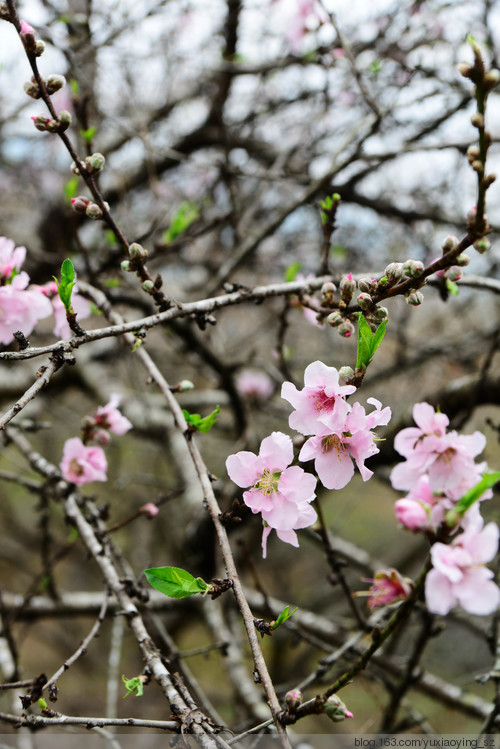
[226,432,316,556]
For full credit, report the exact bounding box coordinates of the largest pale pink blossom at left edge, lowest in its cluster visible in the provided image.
[0,271,51,344]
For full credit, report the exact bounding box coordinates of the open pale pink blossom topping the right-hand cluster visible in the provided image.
[391,403,486,493]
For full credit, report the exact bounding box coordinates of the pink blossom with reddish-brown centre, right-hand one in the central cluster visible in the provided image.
[299,398,391,489]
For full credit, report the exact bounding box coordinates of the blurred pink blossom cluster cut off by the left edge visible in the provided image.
[0,237,90,345]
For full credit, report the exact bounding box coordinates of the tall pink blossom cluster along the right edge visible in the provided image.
[391,403,500,614]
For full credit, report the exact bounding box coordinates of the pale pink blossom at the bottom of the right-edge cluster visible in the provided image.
[425,511,500,615]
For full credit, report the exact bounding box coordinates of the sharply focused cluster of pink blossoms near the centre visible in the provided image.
[226,361,391,557]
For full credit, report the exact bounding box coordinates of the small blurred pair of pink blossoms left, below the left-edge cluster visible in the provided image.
[59,395,132,486]
